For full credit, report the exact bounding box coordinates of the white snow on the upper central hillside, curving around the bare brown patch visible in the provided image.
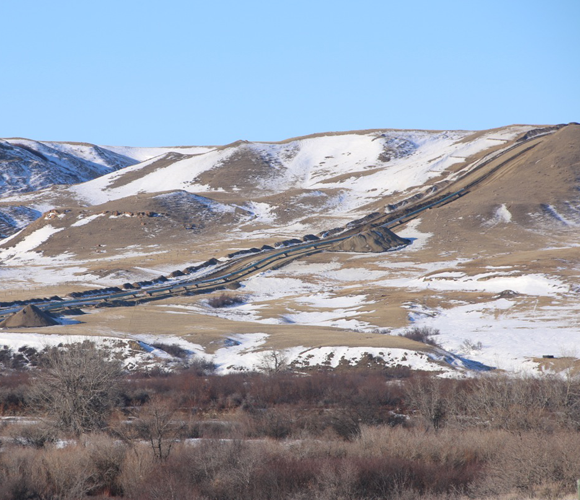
[68,128,532,213]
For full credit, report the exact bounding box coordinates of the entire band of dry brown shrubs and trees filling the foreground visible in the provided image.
[0,346,580,500]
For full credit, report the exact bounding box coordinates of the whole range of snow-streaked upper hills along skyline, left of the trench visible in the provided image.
[0,126,532,242]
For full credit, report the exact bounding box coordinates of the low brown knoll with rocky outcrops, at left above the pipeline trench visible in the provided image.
[0,191,247,256]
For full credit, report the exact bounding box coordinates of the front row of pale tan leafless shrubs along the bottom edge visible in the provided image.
[0,426,580,500]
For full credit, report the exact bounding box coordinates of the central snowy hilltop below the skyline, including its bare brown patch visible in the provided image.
[73,127,530,210]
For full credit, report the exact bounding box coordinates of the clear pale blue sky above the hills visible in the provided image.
[0,0,580,146]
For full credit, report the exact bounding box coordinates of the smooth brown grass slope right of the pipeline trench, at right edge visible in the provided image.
[414,124,580,255]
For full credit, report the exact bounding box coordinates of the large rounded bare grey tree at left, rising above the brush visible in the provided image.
[31,342,122,435]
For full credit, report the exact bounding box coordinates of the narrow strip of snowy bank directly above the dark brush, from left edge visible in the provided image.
[0,332,473,376]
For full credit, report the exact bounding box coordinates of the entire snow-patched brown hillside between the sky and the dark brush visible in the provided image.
[0,124,580,374]
